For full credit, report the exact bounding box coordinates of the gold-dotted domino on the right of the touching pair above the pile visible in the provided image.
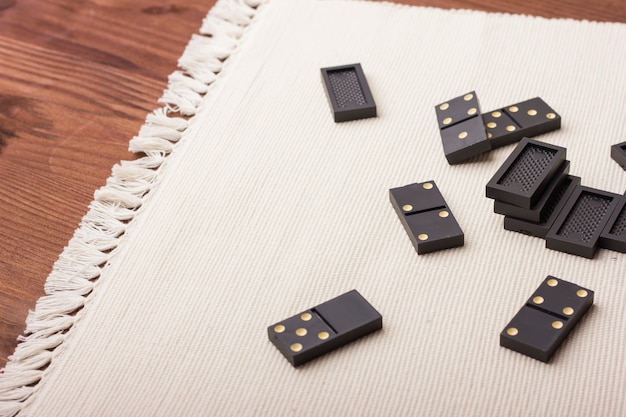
[483,97,561,149]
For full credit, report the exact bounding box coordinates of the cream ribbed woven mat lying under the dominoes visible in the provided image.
[0,0,626,417]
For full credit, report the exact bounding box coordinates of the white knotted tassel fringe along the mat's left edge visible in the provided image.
[0,0,266,417]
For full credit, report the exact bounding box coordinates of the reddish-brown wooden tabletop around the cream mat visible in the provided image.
[0,0,626,368]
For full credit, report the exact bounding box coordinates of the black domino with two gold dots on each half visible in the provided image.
[389,181,464,255]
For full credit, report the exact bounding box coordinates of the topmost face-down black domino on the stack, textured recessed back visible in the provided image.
[487,138,566,209]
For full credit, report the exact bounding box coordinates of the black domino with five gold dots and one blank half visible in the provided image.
[267,290,383,367]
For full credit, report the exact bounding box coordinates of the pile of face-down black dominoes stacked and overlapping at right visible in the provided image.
[487,138,626,259]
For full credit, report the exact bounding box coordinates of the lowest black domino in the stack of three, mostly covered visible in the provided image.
[504,175,580,239]
